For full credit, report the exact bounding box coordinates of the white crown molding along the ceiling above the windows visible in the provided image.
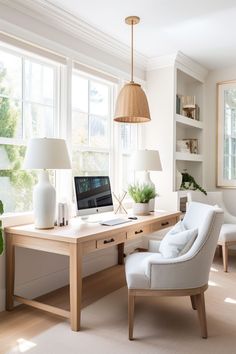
[1,0,147,70]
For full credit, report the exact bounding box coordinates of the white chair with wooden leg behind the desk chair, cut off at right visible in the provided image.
[188,191,236,272]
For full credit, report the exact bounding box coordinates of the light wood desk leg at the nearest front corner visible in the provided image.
[70,243,82,331]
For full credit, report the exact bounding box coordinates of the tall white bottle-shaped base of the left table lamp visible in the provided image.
[33,170,56,229]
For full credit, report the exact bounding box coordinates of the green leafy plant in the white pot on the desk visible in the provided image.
[128,184,157,203]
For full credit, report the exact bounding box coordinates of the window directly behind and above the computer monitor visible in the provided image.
[72,72,112,175]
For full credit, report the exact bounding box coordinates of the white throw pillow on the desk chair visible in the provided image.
[159,222,198,258]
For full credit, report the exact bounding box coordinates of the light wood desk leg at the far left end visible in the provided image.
[6,234,15,311]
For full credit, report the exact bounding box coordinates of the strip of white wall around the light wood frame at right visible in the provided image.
[204,65,236,215]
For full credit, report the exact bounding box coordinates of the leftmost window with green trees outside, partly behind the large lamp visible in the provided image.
[0,47,57,212]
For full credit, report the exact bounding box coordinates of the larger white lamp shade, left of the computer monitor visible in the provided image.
[23,138,71,170]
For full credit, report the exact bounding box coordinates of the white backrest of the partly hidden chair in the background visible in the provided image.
[187,191,236,223]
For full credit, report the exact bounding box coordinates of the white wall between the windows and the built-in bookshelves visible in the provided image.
[144,66,176,210]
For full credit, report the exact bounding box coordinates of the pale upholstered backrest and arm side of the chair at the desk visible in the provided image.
[150,202,224,289]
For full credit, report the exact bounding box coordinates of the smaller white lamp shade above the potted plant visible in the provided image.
[133,150,162,171]
